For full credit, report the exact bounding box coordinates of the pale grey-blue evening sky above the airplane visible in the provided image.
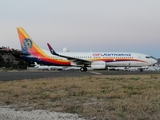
[0,0,160,58]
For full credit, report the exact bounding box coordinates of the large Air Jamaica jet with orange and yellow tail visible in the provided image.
[17,27,157,71]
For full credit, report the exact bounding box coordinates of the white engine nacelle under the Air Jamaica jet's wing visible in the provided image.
[91,61,106,69]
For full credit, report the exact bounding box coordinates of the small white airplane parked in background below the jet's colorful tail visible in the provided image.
[34,62,66,70]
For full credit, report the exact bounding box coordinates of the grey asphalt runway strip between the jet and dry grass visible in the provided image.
[0,70,160,81]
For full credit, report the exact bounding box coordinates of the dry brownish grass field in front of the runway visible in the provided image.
[0,74,160,120]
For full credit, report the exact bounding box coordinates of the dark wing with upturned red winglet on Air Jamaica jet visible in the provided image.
[47,43,91,65]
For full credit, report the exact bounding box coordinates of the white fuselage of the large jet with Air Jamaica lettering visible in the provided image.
[42,51,157,67]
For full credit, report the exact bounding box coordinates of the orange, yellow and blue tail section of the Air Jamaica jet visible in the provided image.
[17,27,70,66]
